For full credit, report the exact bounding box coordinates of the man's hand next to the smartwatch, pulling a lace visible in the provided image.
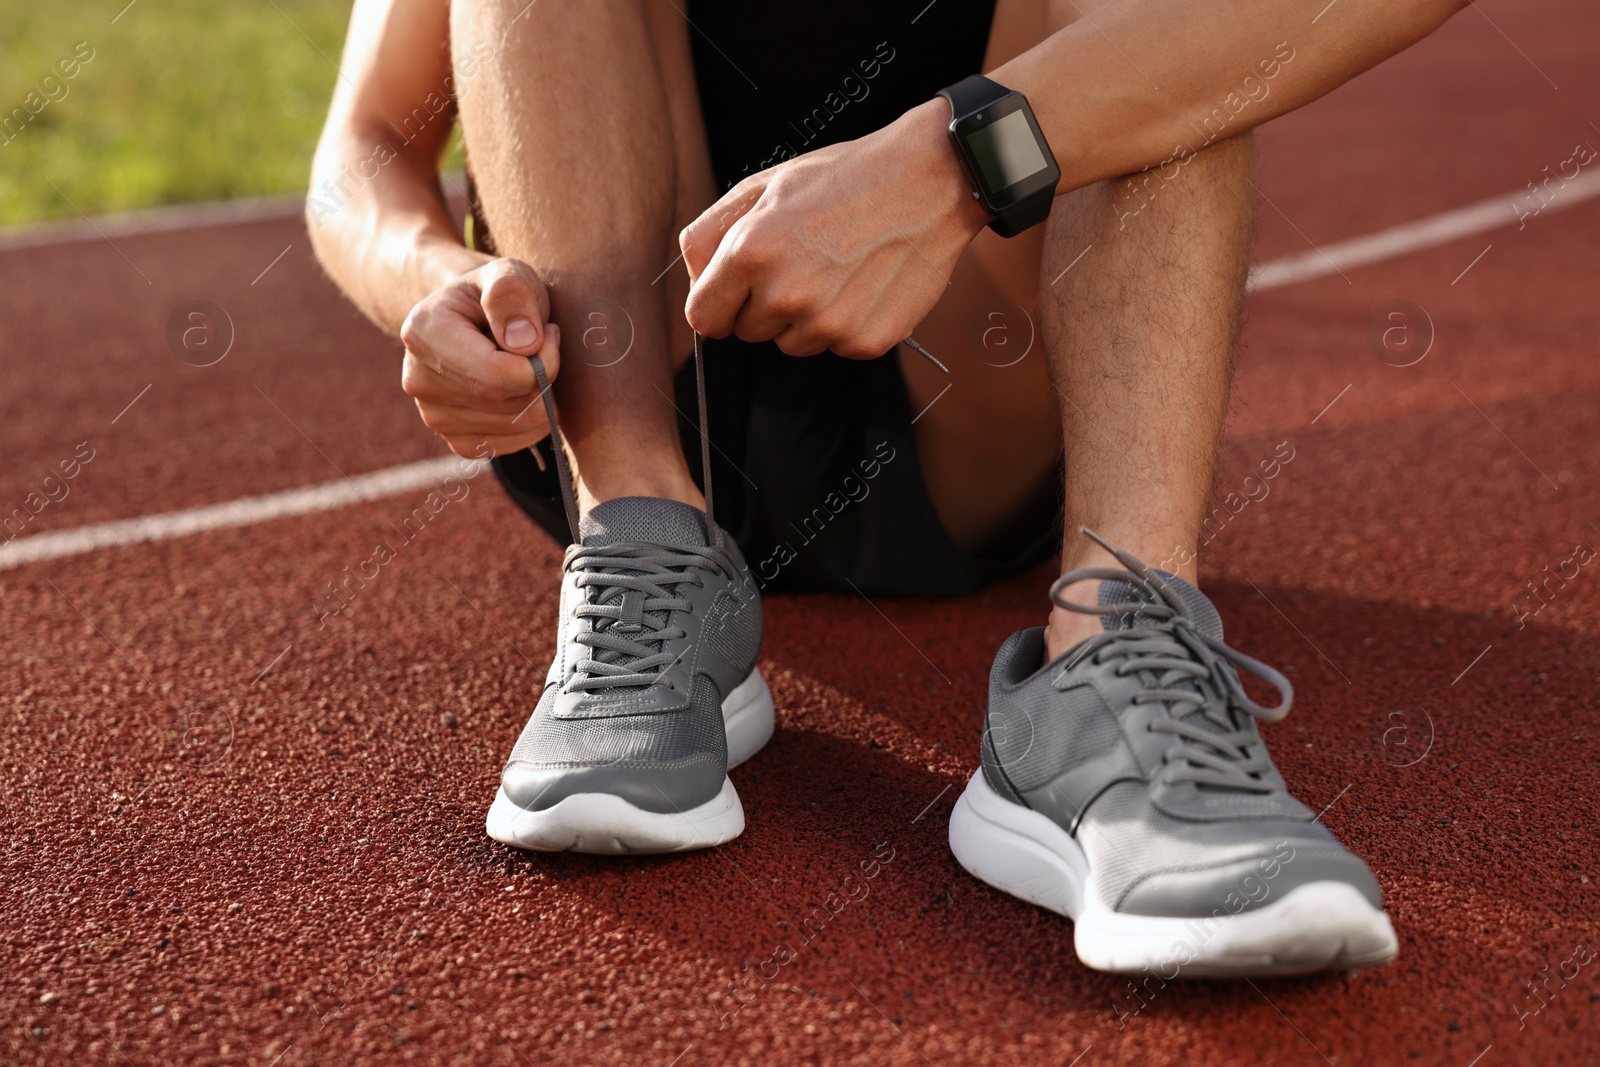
[680,101,989,360]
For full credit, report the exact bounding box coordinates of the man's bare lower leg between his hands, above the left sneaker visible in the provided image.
[451,0,715,510]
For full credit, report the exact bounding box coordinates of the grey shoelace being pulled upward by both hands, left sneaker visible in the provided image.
[531,333,734,691]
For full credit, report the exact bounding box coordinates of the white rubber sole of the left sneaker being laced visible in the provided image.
[486,669,773,854]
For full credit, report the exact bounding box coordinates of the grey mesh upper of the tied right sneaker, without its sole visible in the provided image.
[982,557,1381,917]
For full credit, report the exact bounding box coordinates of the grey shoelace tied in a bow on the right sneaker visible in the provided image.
[1050,528,1294,793]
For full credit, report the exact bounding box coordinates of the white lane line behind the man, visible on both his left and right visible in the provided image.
[0,171,1600,575]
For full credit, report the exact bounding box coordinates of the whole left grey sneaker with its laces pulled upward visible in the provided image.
[488,339,773,853]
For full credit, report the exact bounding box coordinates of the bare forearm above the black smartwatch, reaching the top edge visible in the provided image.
[1011,0,1466,192]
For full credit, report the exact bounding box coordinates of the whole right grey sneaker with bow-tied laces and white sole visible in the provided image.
[950,531,1398,981]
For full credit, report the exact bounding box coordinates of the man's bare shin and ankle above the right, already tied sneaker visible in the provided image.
[1042,134,1254,656]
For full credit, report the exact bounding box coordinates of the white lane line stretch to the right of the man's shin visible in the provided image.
[1250,171,1600,293]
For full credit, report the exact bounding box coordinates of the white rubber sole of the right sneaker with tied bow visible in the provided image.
[950,771,1398,981]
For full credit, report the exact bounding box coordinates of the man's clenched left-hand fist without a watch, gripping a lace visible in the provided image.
[400,258,562,458]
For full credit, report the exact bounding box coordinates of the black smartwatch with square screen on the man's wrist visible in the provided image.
[939,74,1061,237]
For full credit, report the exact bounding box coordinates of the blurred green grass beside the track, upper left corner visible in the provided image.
[0,0,377,226]
